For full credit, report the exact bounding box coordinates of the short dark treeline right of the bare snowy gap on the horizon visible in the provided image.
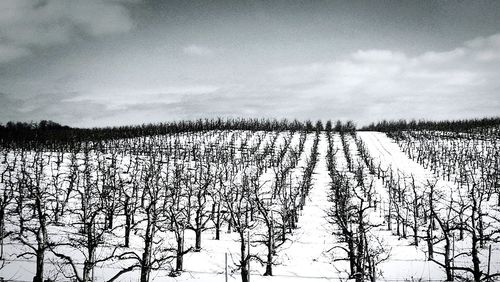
[359,117,500,132]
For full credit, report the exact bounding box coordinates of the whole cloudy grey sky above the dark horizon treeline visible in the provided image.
[0,0,500,127]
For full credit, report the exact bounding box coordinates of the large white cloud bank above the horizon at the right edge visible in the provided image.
[269,34,500,120]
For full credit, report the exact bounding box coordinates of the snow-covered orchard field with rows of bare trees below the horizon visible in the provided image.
[0,131,500,282]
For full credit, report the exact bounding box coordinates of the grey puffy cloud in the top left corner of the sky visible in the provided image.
[0,0,133,62]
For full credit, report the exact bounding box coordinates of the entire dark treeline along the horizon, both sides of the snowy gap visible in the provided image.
[0,117,500,148]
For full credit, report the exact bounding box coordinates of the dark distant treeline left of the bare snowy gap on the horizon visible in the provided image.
[0,118,356,148]
